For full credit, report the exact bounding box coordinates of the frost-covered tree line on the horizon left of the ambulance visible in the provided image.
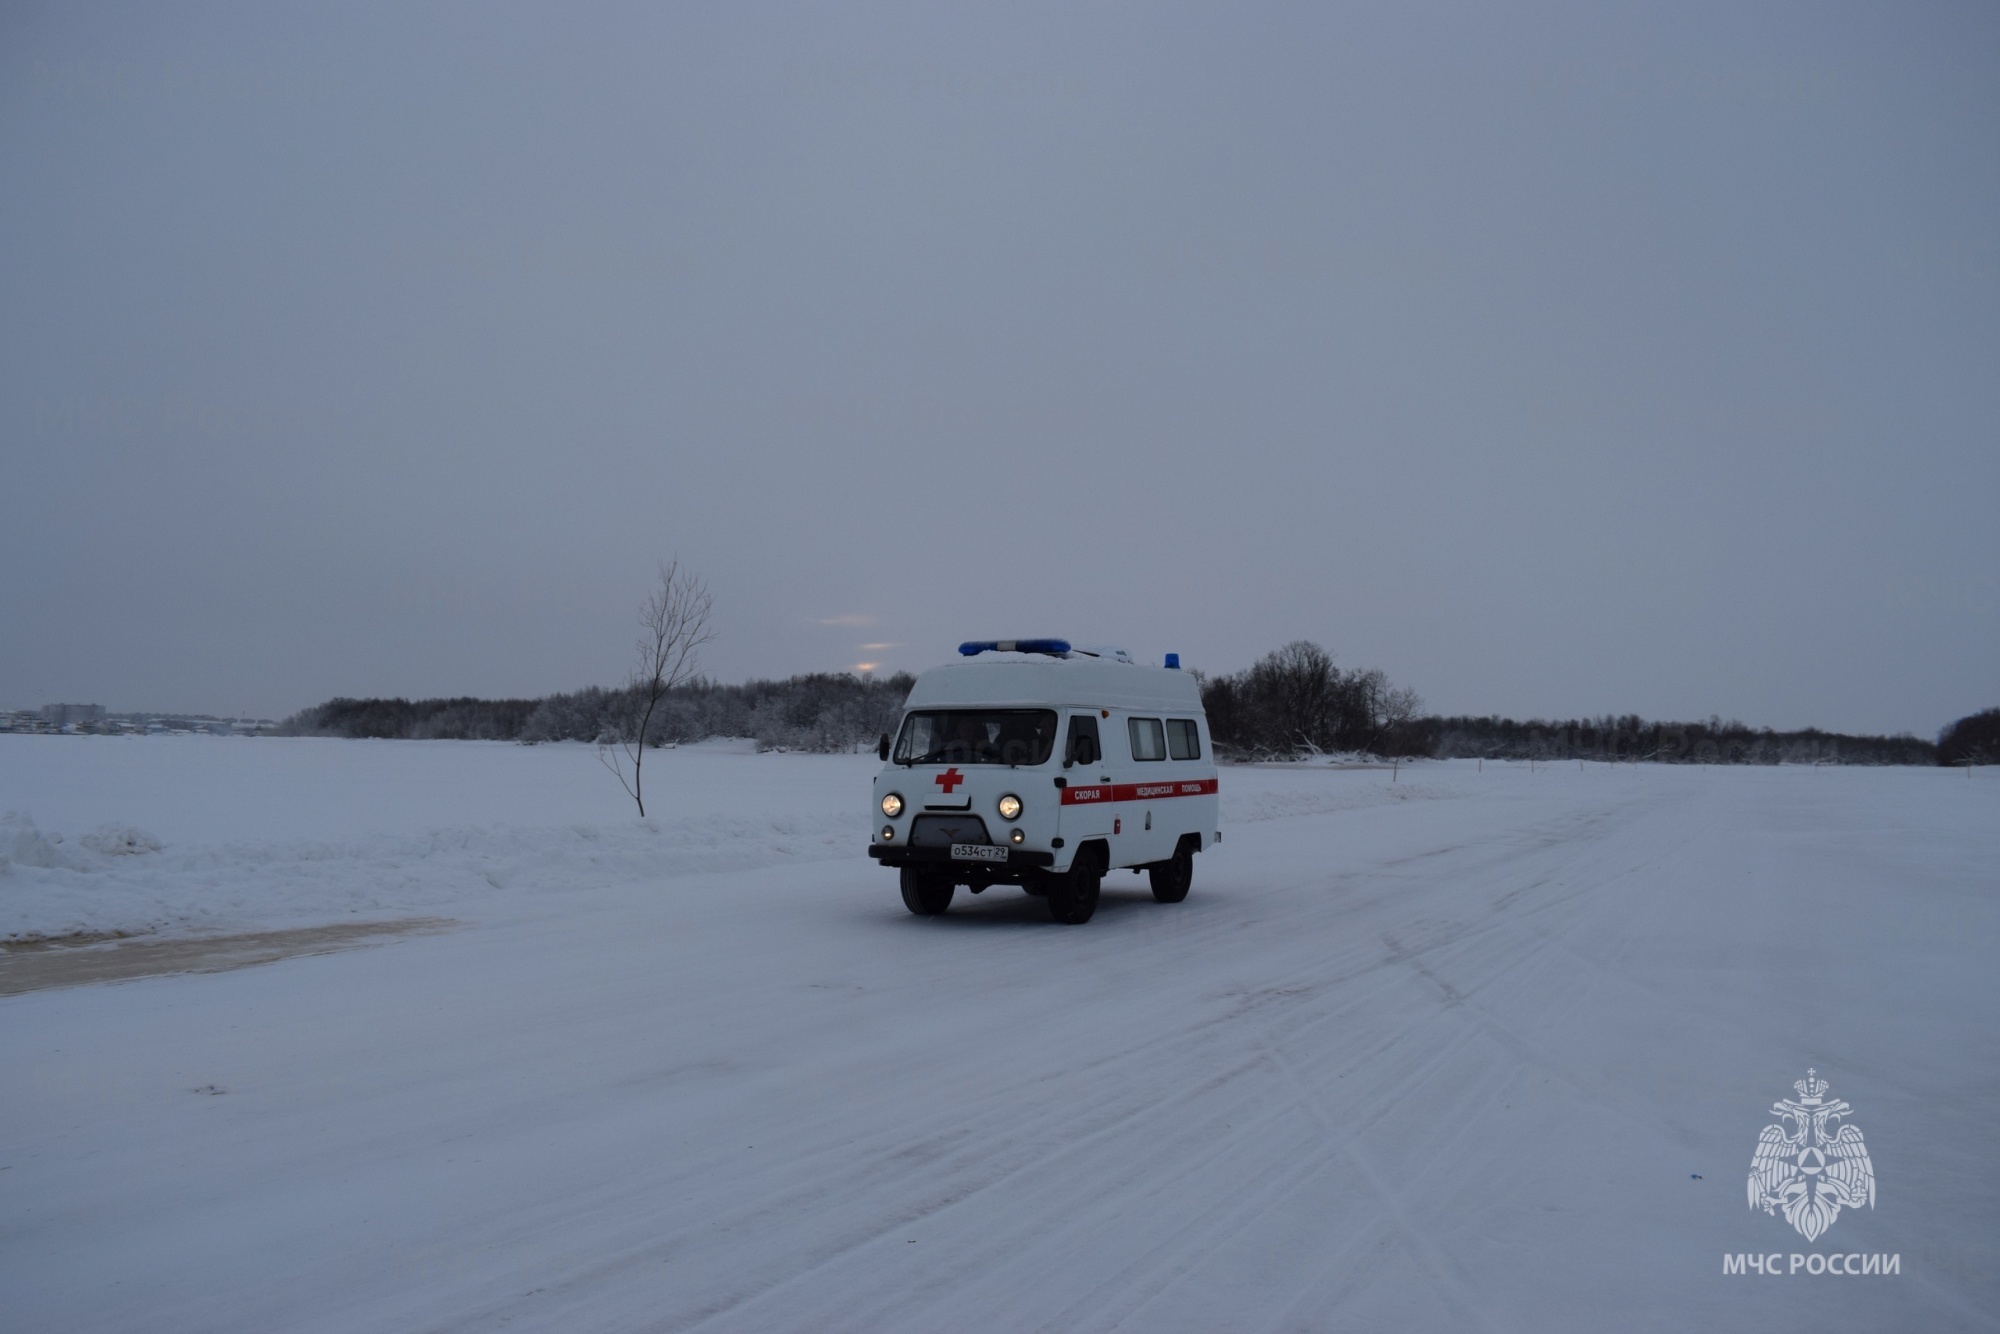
[278,672,916,752]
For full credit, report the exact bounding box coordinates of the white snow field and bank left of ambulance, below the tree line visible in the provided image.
[0,736,876,940]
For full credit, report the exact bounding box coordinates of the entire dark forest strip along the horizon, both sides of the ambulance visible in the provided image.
[278,640,1968,764]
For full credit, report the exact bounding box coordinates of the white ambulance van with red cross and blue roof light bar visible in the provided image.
[868,640,1222,924]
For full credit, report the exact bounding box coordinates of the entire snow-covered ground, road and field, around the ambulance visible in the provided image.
[0,736,2000,1332]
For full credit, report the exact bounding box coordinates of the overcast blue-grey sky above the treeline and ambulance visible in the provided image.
[0,2,2000,734]
